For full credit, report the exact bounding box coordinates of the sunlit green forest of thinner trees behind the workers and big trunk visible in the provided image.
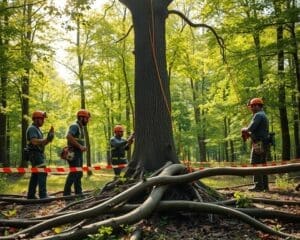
[0,0,300,166]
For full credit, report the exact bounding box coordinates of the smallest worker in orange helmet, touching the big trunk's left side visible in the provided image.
[110,125,134,179]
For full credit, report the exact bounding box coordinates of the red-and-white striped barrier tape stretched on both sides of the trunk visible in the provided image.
[0,159,300,173]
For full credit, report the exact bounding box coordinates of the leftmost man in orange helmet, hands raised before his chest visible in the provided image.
[25,110,54,199]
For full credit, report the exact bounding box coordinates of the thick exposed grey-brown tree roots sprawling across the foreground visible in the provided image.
[1,164,300,239]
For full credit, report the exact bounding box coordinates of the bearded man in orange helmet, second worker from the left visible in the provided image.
[63,109,91,196]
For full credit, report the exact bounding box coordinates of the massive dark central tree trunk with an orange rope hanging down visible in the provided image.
[120,0,178,174]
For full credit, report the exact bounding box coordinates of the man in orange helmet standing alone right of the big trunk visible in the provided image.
[242,98,270,191]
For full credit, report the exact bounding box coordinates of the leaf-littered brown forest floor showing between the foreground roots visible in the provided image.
[0,175,300,240]
